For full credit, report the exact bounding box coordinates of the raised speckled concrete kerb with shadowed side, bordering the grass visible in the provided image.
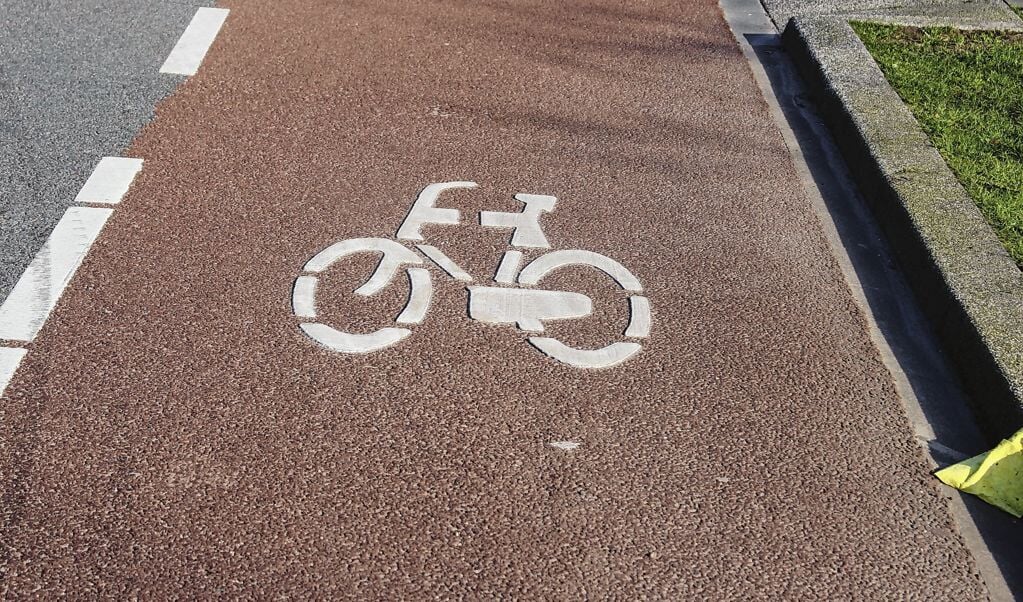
[782,16,1023,441]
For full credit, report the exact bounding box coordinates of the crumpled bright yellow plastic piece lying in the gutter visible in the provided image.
[934,430,1023,518]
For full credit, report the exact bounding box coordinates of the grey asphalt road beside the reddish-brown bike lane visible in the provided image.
[0,0,210,300]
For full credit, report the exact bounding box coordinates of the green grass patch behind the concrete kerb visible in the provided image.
[853,23,1023,269]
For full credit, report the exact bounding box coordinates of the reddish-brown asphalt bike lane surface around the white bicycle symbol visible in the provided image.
[0,0,984,599]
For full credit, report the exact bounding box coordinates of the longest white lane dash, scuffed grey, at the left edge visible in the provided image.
[0,207,114,342]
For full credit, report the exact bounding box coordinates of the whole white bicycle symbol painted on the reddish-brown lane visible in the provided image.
[292,181,652,369]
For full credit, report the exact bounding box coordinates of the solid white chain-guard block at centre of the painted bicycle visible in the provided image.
[469,287,593,333]
